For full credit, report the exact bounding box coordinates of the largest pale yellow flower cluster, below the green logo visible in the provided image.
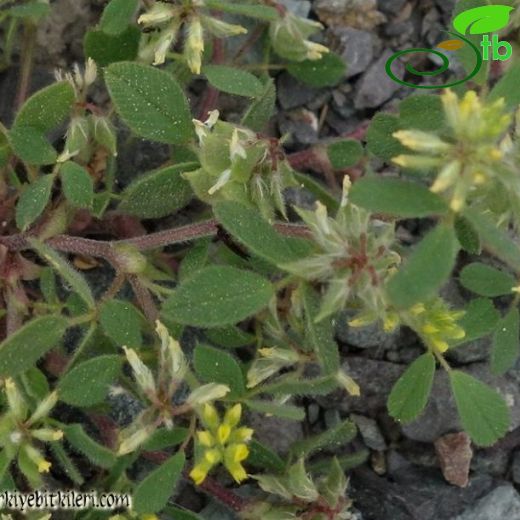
[393,90,513,212]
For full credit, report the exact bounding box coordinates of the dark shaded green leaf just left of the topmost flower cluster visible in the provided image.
[83,25,141,67]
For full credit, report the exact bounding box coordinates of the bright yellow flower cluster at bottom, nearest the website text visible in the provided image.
[190,404,253,485]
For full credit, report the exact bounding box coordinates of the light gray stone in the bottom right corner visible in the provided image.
[454,484,520,520]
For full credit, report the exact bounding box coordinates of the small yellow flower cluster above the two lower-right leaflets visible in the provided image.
[405,298,466,354]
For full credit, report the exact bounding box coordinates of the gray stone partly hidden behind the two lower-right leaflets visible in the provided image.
[403,363,520,442]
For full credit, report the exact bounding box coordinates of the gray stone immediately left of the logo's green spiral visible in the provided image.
[354,50,404,108]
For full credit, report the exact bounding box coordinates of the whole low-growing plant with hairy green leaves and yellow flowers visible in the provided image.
[0,0,520,520]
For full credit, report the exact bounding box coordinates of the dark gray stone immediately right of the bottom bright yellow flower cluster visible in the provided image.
[244,412,303,454]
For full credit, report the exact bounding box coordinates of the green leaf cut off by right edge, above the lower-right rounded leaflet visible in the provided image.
[491,308,520,374]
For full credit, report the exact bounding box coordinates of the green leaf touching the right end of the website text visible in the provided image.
[133,452,186,514]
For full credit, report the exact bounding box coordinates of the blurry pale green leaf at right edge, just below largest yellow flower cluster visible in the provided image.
[464,208,520,272]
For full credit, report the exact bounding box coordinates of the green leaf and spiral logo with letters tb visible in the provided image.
[386,5,513,89]
